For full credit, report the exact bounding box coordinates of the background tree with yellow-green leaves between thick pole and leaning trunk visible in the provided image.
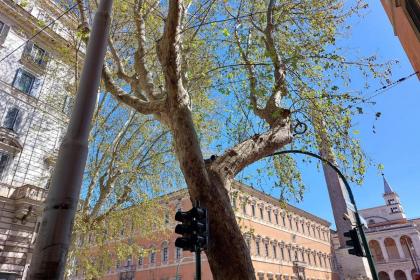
[67,94,177,279]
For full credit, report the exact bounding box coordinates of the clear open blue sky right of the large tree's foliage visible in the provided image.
[280,0,420,228]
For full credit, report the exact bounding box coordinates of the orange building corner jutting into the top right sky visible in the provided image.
[381,0,420,79]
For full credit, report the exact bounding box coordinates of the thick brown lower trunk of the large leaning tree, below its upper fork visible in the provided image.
[170,105,255,280]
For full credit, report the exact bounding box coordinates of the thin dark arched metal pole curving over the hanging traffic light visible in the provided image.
[267,150,379,280]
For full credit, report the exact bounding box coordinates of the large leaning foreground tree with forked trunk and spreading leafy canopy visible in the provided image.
[73,0,389,279]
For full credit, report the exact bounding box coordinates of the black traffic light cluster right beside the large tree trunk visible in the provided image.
[175,207,208,252]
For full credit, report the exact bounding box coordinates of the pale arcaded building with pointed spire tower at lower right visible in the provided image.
[360,178,420,280]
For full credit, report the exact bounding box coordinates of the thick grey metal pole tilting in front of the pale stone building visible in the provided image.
[29,0,113,279]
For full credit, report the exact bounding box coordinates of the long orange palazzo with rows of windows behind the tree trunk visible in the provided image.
[87,182,338,280]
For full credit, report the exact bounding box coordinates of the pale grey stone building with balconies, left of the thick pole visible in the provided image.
[0,0,81,279]
